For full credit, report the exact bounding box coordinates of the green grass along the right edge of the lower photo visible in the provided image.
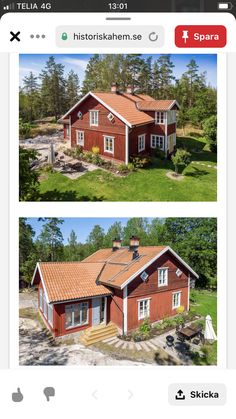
[190,290,217,365]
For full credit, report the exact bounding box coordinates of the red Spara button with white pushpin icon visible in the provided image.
[175,25,227,48]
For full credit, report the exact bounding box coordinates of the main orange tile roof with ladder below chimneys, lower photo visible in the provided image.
[82,246,166,288]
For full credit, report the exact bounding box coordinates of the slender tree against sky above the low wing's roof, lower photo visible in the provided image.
[38,218,64,262]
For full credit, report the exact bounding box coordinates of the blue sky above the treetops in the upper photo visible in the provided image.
[20,54,217,87]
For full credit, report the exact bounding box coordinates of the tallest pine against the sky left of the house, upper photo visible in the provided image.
[39,56,67,121]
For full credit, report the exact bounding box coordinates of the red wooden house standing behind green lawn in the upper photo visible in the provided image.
[60,84,179,164]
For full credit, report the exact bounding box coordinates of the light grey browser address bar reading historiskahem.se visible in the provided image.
[56,25,164,48]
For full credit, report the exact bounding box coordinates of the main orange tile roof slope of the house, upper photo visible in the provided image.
[93,92,154,125]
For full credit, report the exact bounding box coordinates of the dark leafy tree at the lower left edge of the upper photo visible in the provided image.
[19,147,39,201]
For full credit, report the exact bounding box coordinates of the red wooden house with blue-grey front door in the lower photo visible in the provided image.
[32,237,198,337]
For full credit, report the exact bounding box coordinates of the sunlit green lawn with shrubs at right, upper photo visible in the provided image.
[37,136,217,201]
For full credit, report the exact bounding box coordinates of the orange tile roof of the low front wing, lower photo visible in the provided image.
[39,262,111,302]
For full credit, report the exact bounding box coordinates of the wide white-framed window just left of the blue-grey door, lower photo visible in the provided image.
[65,302,88,329]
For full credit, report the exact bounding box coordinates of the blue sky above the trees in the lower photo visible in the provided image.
[27,218,157,244]
